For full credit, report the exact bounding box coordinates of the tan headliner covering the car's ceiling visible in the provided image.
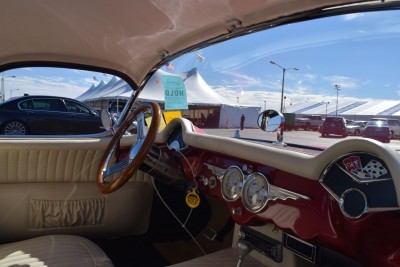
[0,0,360,84]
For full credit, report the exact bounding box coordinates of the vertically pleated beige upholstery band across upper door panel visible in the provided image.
[0,149,103,183]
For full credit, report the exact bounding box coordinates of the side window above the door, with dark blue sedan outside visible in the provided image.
[0,66,134,138]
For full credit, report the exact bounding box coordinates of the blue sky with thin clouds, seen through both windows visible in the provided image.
[4,8,400,108]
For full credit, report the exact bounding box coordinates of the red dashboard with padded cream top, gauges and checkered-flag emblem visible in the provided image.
[156,119,400,262]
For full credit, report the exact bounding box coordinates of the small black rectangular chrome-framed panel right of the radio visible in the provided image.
[283,233,320,263]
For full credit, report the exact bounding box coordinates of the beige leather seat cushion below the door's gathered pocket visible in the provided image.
[0,235,114,267]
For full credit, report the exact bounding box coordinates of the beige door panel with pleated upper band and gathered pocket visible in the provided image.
[0,138,153,242]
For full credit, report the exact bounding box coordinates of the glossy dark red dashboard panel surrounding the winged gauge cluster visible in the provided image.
[183,150,400,266]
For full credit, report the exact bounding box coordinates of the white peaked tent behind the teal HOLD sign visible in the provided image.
[76,68,261,128]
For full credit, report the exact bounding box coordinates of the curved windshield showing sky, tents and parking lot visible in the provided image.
[141,8,400,150]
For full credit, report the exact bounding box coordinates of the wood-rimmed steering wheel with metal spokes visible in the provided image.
[97,102,161,194]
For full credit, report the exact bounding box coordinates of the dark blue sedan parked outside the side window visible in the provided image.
[0,96,104,135]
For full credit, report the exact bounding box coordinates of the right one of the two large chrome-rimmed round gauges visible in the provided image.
[242,173,269,213]
